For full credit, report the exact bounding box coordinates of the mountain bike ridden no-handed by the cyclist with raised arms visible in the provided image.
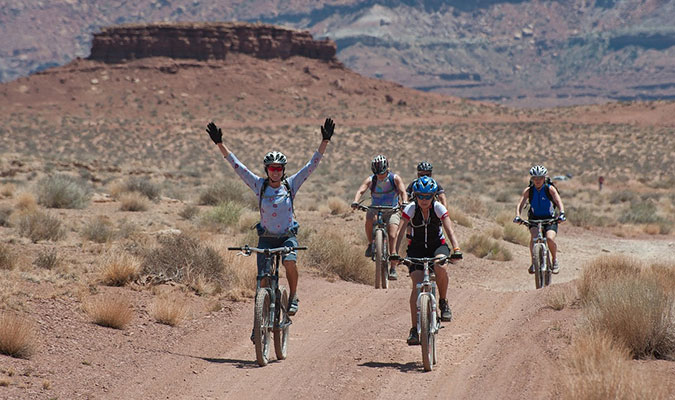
[227,245,307,367]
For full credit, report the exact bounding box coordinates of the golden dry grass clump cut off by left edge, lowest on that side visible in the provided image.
[0,313,37,359]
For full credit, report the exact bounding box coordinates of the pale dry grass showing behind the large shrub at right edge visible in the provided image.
[577,255,641,303]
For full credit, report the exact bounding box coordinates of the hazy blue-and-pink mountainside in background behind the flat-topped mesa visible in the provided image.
[0,0,675,106]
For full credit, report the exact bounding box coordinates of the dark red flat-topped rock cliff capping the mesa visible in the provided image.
[89,23,337,63]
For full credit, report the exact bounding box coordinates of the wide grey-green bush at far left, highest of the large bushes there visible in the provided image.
[37,174,91,209]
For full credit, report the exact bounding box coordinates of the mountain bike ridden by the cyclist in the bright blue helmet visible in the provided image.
[400,254,461,371]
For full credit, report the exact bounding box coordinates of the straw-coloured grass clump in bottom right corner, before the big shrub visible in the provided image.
[563,332,666,400]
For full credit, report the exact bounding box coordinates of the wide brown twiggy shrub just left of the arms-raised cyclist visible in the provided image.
[142,233,223,285]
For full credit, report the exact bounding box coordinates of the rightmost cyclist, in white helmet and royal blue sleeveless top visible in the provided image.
[513,165,567,274]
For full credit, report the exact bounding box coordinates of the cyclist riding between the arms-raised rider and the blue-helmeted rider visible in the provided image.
[352,155,408,280]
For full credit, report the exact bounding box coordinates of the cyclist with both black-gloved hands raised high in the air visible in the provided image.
[206,118,335,337]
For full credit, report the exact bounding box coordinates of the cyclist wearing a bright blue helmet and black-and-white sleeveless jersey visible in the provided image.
[390,176,462,346]
